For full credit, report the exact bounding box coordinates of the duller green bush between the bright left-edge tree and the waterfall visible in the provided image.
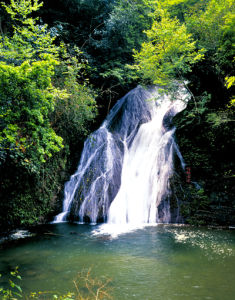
[51,43,97,145]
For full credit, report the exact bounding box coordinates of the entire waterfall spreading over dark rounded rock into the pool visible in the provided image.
[54,86,187,224]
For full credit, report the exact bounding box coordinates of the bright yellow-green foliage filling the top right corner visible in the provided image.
[185,0,235,89]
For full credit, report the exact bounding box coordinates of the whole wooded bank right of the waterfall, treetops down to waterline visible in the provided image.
[164,0,234,225]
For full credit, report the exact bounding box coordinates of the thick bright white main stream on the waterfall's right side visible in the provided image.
[108,99,176,224]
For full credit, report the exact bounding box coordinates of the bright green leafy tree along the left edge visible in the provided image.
[0,0,65,171]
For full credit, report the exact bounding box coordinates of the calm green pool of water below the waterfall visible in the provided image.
[0,223,235,300]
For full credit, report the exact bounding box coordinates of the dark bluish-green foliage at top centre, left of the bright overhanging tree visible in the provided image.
[94,0,152,85]
